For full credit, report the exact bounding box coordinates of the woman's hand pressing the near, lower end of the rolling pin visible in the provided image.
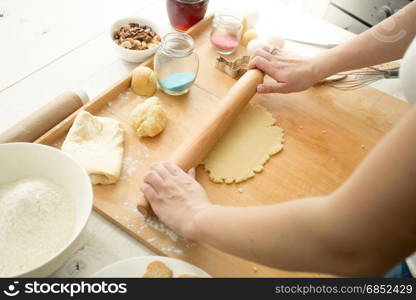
[140,161,213,239]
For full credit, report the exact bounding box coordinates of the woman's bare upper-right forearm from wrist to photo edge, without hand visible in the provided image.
[314,2,416,79]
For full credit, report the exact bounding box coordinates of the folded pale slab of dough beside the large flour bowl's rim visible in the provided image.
[61,111,124,184]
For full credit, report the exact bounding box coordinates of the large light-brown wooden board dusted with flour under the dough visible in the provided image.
[37,18,409,277]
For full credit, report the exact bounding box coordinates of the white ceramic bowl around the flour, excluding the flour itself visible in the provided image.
[0,143,93,277]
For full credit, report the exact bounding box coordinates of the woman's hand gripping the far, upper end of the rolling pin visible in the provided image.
[248,48,326,94]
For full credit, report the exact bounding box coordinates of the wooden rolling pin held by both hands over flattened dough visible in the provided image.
[137,69,264,215]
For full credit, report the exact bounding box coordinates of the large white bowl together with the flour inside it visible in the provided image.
[0,143,93,277]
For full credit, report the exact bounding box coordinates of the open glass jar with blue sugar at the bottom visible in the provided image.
[154,32,199,96]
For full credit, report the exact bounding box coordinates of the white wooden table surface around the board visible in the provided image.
[0,0,403,277]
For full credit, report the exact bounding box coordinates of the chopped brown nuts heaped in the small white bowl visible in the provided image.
[113,23,161,50]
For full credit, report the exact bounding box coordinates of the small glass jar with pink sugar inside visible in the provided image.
[211,9,243,55]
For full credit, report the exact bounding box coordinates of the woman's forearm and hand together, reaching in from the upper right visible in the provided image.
[248,2,416,93]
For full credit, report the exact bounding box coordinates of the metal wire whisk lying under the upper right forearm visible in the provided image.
[321,67,399,91]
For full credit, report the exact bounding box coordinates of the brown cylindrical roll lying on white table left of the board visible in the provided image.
[0,91,89,144]
